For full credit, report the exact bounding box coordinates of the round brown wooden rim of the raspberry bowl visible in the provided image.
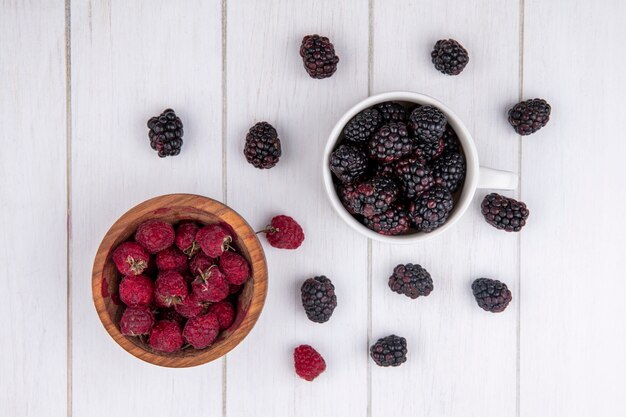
[91,194,268,368]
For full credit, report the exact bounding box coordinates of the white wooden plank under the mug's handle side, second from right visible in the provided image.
[370,0,519,417]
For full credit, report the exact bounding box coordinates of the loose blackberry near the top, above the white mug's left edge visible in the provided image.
[300,35,339,79]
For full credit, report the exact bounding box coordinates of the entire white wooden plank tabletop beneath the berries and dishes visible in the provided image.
[0,0,626,417]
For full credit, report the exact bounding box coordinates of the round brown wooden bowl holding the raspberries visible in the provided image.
[91,194,267,368]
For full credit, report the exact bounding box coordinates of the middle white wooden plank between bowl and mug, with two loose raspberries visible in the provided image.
[227,0,368,417]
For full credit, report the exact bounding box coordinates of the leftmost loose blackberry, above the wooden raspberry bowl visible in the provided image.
[148,109,183,158]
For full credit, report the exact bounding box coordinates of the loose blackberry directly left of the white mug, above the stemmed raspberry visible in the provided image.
[243,122,282,169]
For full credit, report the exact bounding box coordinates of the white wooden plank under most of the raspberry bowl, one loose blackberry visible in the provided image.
[72,0,223,417]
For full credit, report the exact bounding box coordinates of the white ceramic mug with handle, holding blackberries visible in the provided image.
[322,91,518,240]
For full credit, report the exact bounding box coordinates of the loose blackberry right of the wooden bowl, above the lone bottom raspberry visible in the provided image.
[300,275,337,323]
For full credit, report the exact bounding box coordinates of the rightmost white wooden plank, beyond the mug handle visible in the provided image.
[520,0,626,417]
